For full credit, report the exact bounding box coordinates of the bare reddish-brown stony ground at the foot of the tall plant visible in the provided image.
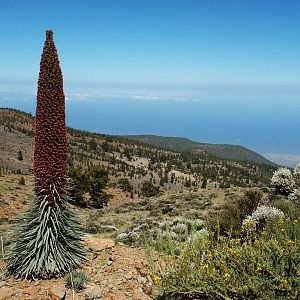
[0,236,156,300]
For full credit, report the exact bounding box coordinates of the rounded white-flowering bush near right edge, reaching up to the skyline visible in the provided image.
[271,168,295,195]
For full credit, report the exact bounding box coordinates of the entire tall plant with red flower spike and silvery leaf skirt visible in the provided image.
[7,30,85,278]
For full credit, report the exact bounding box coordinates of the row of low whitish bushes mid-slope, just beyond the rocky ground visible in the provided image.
[116,217,208,246]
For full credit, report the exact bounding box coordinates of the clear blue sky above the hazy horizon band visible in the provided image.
[0,0,300,84]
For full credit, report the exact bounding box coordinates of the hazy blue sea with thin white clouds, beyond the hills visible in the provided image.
[0,82,300,166]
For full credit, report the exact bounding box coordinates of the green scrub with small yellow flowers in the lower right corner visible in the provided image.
[150,204,300,299]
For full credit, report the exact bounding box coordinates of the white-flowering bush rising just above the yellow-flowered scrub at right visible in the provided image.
[242,206,284,234]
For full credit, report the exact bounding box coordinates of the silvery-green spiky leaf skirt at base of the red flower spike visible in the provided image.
[7,187,85,279]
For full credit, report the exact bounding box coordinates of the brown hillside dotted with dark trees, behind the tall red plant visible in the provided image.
[0,109,274,196]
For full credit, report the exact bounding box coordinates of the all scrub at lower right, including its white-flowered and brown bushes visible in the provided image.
[148,165,300,300]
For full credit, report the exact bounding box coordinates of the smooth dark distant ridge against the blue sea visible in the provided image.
[125,135,276,166]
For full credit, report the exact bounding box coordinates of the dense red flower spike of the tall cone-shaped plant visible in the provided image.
[33,30,67,204]
